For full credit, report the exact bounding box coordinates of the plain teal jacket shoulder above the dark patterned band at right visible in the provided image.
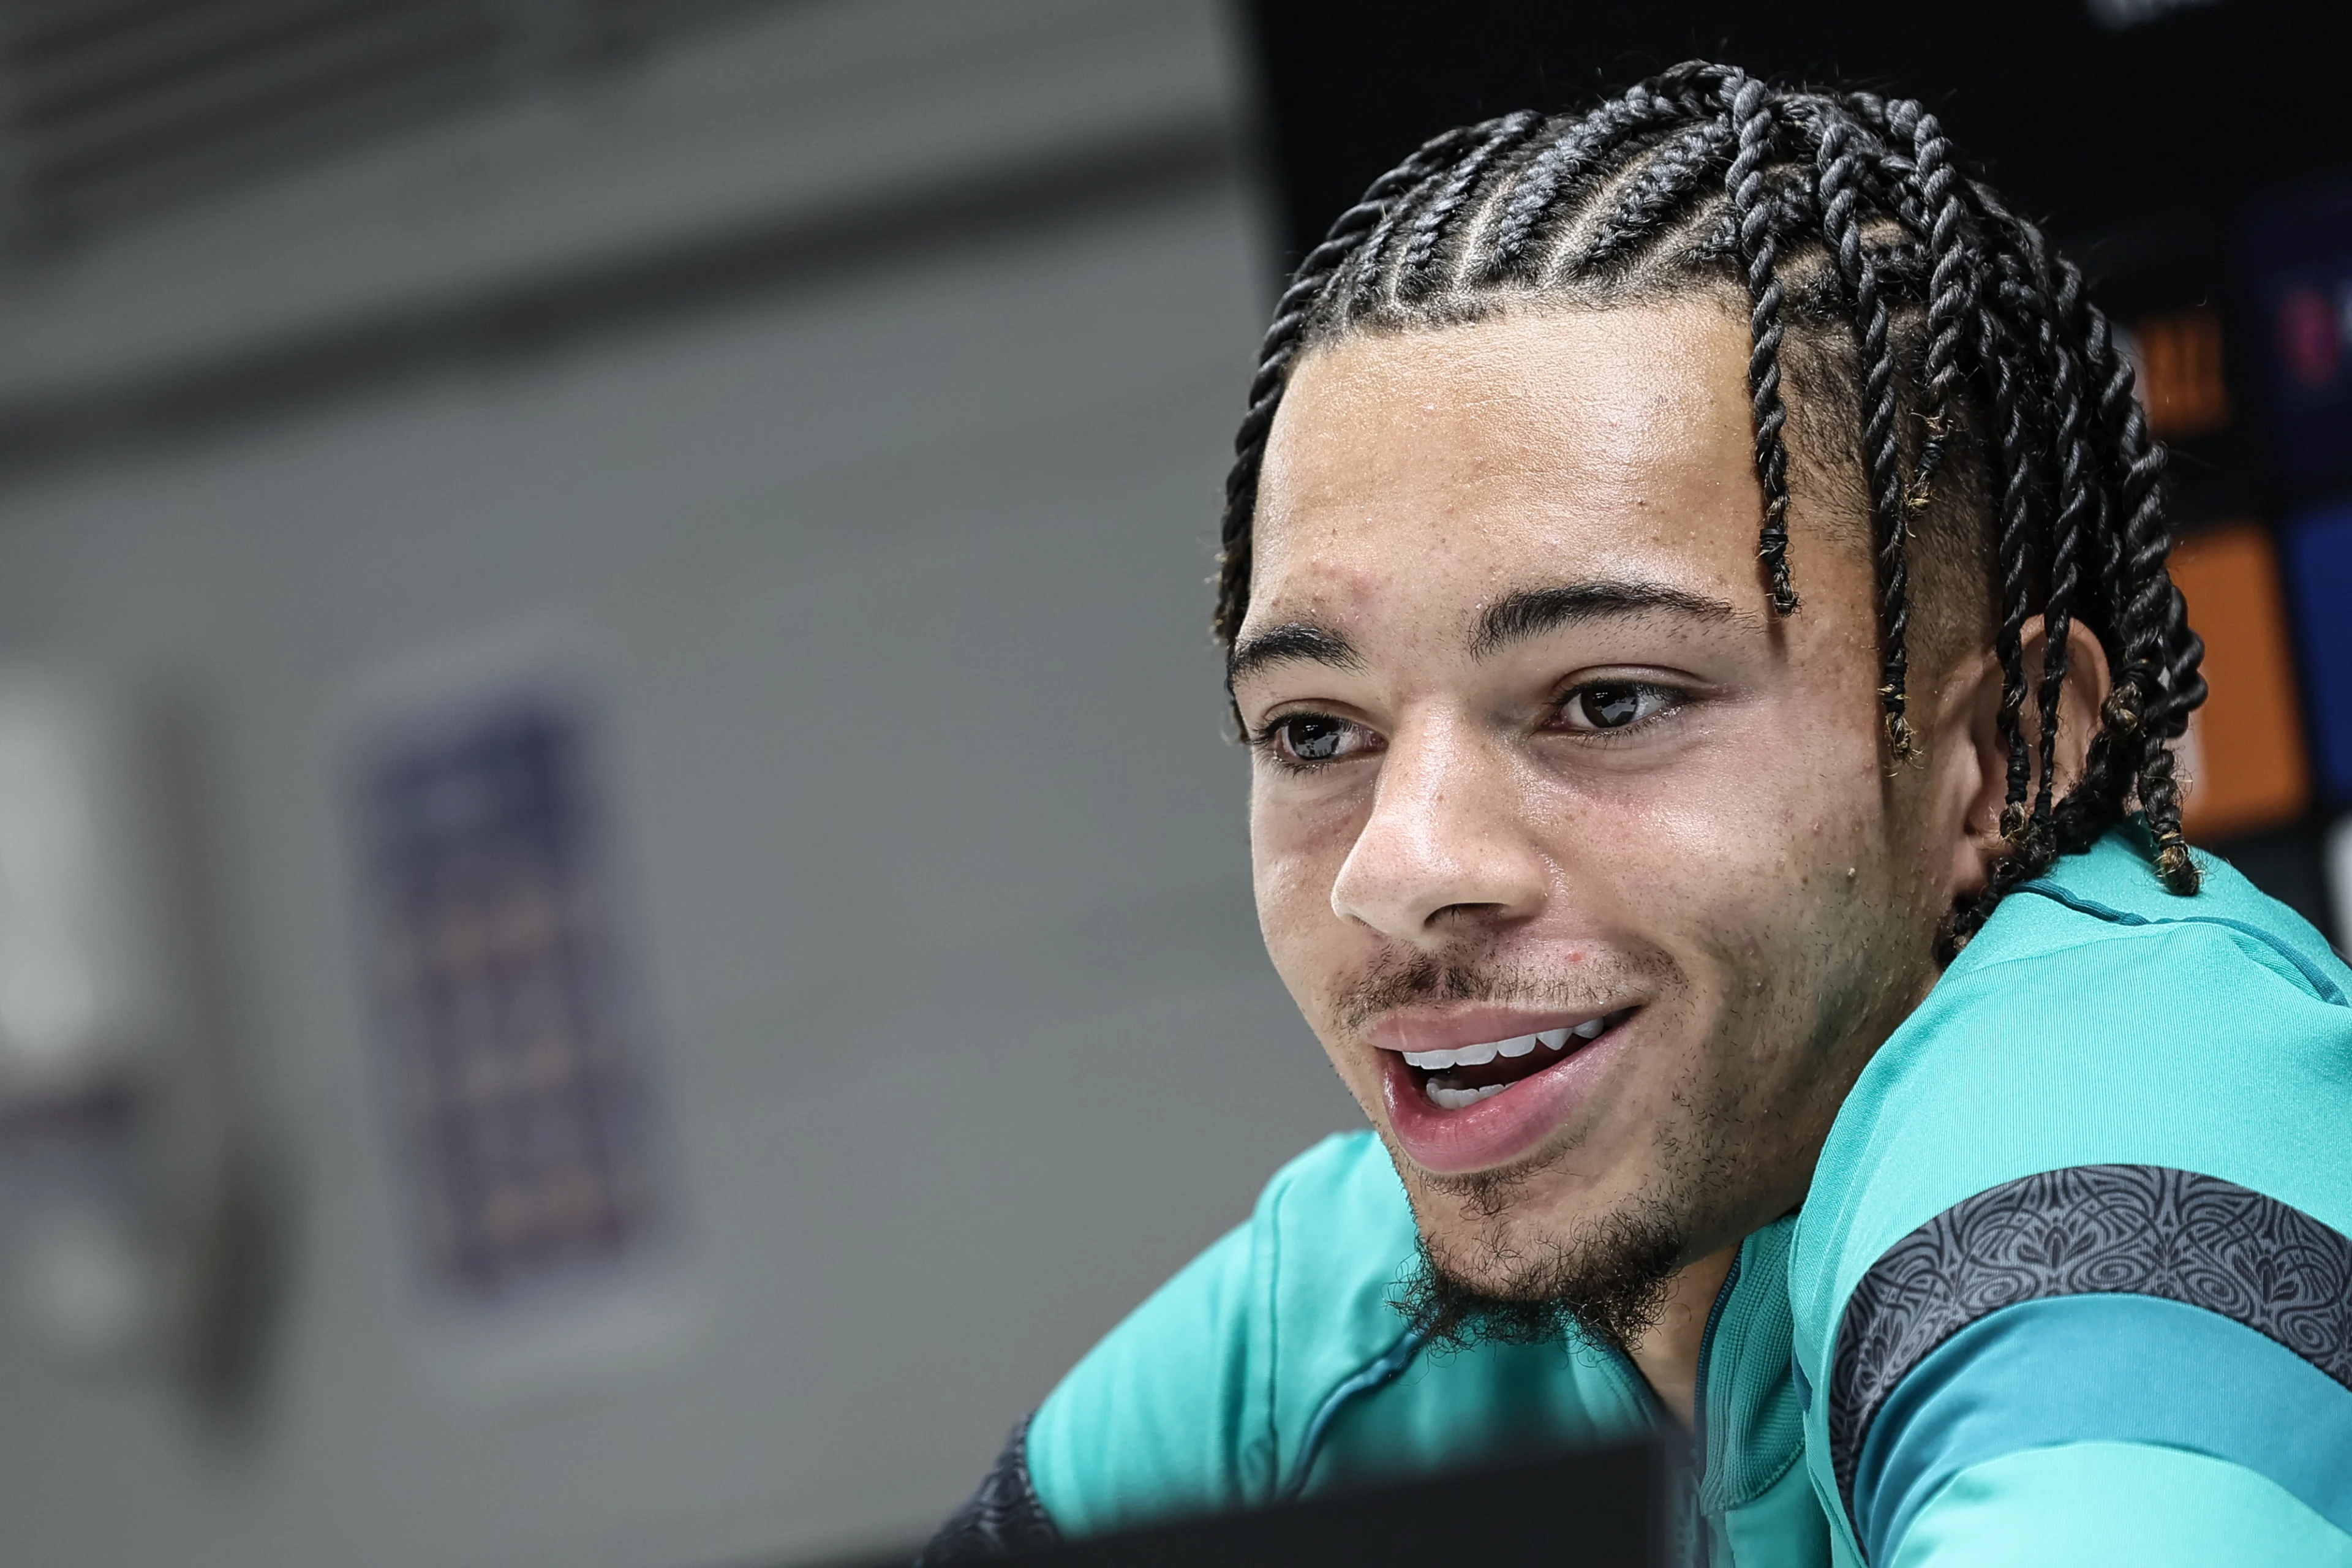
[1792,846,2352,1340]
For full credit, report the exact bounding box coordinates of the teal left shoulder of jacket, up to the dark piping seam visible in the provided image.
[1028,1131,1414,1535]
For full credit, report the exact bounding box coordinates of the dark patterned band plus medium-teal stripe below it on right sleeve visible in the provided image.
[1828,1166,2352,1563]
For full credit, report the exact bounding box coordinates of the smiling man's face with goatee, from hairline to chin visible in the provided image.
[1235,298,1952,1295]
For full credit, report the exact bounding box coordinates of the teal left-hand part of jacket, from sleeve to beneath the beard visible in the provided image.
[1025,1133,1675,1537]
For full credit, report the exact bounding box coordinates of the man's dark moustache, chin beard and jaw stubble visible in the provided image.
[1329,799,1933,1349]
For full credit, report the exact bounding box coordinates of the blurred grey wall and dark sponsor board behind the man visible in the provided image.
[0,0,2352,1568]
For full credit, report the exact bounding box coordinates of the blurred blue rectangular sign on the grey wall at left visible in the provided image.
[355,687,668,1302]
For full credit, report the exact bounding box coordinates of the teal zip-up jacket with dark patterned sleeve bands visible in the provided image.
[927,830,2352,1568]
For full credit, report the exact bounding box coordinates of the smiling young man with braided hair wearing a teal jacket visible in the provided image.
[929,66,2352,1568]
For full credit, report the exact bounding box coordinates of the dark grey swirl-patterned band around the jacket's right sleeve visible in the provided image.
[1830,1166,2352,1518]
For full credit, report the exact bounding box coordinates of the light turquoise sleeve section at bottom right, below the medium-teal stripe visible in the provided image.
[1893,1444,2352,1568]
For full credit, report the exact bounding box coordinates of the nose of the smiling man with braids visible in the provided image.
[1331,719,1550,952]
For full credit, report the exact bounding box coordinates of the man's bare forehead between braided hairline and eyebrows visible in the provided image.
[1249,296,1762,644]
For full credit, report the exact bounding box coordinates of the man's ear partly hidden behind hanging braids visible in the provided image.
[1931,616,2114,903]
